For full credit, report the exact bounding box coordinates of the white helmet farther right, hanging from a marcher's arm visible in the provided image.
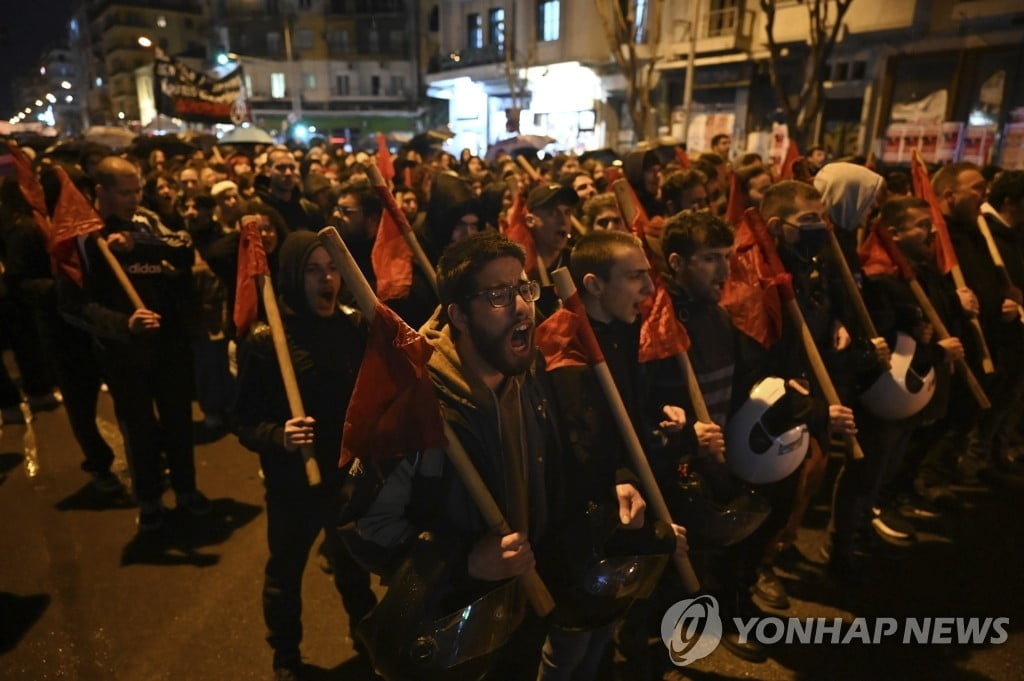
[860,334,935,421]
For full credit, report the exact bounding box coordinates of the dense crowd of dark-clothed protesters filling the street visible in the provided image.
[0,129,1024,680]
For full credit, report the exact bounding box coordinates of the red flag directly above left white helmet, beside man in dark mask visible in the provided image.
[722,209,792,347]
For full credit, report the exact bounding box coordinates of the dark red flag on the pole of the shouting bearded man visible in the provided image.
[338,301,447,468]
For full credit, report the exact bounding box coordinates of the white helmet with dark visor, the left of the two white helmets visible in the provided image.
[725,376,811,484]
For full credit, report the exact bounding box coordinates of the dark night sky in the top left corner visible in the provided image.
[0,0,73,115]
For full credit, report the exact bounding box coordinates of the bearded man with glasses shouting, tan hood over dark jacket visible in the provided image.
[358,231,565,681]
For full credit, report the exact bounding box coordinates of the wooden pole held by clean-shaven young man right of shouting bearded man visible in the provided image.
[552,267,700,593]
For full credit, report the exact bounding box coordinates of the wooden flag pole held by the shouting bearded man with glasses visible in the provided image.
[316,227,555,616]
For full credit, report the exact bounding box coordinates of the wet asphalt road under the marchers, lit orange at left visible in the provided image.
[0,387,1024,681]
